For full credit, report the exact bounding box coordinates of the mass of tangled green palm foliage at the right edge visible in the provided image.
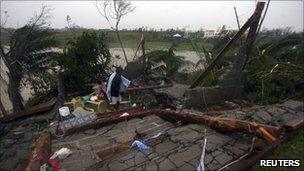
[247,34,304,103]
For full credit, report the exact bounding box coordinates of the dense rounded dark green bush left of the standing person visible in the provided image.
[57,32,110,93]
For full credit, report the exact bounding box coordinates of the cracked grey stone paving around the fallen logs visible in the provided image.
[0,101,304,170]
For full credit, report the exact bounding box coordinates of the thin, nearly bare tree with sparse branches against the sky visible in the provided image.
[96,0,135,65]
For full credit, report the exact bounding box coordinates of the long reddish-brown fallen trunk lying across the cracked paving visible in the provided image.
[63,109,284,144]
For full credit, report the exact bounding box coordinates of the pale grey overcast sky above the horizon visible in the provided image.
[1,1,303,31]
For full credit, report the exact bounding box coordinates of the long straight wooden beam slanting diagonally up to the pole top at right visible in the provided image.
[190,2,265,89]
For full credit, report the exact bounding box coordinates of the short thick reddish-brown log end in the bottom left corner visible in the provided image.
[25,132,51,171]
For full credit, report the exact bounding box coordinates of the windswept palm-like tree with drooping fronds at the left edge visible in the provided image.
[0,6,56,111]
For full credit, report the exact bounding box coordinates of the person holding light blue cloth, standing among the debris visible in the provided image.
[106,67,131,110]
